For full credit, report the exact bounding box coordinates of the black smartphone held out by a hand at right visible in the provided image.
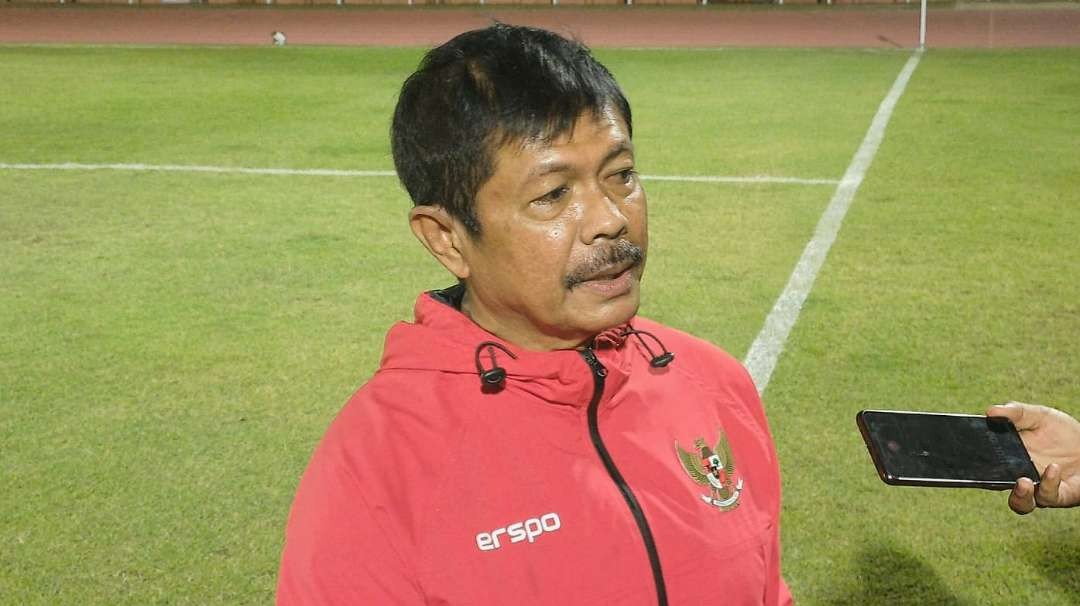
[855,410,1039,489]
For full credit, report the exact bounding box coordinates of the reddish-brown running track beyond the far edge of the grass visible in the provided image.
[0,3,1080,49]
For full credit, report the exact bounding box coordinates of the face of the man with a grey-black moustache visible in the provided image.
[461,111,648,350]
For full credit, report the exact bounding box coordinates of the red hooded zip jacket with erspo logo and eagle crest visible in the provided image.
[278,294,791,606]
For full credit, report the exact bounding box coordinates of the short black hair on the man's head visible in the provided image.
[391,24,633,235]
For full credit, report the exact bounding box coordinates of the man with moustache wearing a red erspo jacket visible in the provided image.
[278,25,791,605]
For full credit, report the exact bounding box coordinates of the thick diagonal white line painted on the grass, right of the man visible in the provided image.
[745,51,922,393]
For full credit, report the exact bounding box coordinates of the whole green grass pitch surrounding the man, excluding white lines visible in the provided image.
[0,46,1080,605]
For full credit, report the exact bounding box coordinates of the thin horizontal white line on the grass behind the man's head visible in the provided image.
[0,162,840,185]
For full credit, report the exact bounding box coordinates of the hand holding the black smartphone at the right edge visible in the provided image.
[986,402,1080,514]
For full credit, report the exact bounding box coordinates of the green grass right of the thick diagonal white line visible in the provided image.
[768,51,1080,605]
